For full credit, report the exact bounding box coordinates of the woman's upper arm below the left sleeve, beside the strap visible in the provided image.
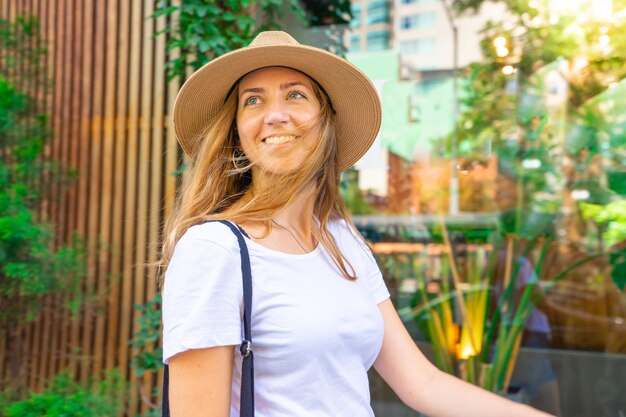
[169,346,234,417]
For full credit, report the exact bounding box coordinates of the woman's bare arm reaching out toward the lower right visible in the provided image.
[374,299,549,417]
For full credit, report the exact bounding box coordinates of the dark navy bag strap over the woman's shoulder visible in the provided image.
[161,220,254,417]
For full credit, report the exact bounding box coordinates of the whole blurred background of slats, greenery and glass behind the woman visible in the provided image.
[0,0,626,417]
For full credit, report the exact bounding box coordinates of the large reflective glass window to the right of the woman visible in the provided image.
[342,5,626,417]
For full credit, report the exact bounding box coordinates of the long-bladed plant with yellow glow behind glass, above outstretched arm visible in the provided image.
[411,223,604,393]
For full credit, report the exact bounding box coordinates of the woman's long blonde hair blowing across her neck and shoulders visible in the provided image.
[159,77,358,280]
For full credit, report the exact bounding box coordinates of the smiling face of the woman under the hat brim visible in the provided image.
[237,67,321,174]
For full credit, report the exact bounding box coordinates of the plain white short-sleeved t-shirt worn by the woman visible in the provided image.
[158,221,389,417]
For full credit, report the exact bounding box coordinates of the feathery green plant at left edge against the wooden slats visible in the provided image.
[0,17,85,391]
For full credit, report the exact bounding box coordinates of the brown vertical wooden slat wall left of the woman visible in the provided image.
[0,0,180,415]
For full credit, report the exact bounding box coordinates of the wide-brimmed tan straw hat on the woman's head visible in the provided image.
[174,31,381,171]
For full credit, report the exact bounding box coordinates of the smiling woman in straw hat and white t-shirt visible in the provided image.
[163,32,547,417]
